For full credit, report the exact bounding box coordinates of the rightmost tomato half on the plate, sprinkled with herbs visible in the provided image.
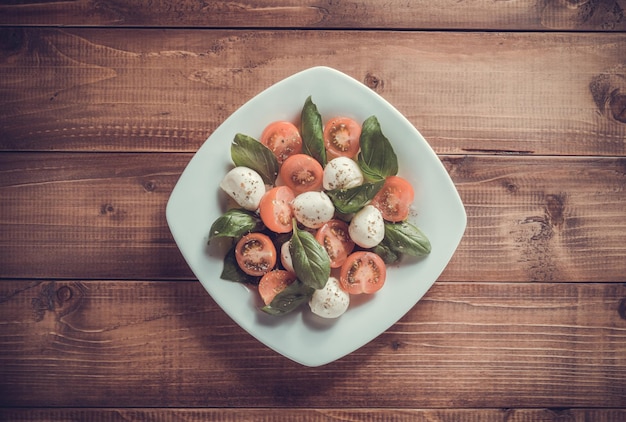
[371,176,415,223]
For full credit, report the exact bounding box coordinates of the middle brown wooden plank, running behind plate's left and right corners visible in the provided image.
[0,153,626,282]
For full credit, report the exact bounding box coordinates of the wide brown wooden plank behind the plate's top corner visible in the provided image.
[0,28,626,156]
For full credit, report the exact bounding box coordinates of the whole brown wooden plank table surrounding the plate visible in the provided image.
[0,0,626,421]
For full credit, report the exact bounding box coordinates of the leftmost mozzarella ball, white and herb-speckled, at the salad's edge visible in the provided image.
[220,166,265,211]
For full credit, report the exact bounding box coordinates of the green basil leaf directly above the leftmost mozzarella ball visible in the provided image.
[230,133,279,185]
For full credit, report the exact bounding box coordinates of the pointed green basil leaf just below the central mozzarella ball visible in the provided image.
[289,219,330,289]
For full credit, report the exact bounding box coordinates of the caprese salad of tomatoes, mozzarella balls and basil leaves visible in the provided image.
[209,97,431,318]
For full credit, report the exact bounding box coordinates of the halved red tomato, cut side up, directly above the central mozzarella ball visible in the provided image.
[280,154,324,195]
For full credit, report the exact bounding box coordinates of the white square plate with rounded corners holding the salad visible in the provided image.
[166,67,466,366]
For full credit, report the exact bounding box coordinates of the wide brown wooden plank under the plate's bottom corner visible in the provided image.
[0,280,626,409]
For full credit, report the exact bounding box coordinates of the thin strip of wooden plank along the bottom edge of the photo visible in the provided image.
[0,408,626,422]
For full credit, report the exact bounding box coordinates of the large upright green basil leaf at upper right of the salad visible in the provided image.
[357,116,398,181]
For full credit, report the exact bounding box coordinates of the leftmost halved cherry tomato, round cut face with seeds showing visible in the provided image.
[235,233,276,276]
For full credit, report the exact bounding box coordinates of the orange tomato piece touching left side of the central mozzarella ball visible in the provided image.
[259,186,296,233]
